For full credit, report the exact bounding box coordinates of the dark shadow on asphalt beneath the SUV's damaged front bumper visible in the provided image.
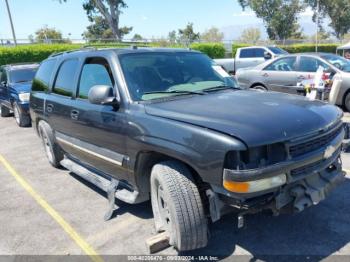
[182,179,350,261]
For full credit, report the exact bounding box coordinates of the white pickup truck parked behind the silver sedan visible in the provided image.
[215,46,288,75]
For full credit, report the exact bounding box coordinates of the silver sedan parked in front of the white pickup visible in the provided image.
[236,53,350,111]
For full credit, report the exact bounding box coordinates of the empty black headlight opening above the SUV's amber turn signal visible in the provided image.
[225,143,287,170]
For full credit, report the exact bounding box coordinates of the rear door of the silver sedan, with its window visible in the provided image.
[261,56,297,94]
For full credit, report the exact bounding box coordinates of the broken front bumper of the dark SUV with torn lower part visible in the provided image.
[207,124,345,222]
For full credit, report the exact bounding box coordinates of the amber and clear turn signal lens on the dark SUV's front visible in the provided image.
[224,174,287,193]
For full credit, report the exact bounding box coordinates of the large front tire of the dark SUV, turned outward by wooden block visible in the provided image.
[151,161,208,251]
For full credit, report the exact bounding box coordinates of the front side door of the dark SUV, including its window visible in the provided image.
[57,56,128,179]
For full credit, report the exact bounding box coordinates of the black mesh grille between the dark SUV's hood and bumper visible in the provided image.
[289,126,343,157]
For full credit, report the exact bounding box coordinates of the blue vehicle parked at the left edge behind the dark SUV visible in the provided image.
[0,64,39,127]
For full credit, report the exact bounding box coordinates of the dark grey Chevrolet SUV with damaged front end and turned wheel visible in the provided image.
[30,48,345,251]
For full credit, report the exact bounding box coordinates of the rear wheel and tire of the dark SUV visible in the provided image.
[38,121,64,168]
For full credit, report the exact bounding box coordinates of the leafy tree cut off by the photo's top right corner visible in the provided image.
[304,0,350,39]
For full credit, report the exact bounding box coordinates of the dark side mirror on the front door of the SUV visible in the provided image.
[88,85,120,107]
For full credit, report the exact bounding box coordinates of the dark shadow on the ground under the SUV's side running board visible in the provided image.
[69,172,153,219]
